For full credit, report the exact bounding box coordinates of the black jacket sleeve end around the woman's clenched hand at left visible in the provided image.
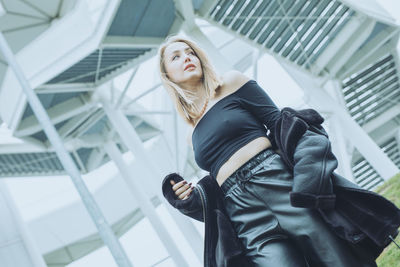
[162,173,204,222]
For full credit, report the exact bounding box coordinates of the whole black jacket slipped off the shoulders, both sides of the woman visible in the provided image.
[163,108,400,267]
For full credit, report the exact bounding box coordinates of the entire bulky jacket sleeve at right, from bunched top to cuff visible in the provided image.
[275,108,337,209]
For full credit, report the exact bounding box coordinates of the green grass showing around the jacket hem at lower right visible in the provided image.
[375,174,400,267]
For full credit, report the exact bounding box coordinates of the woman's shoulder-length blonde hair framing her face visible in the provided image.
[158,35,222,127]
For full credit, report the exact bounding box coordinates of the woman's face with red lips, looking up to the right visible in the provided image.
[164,42,203,87]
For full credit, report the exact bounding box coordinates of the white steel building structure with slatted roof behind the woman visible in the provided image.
[0,0,400,267]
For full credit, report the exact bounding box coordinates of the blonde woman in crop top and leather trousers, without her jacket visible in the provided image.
[159,36,382,267]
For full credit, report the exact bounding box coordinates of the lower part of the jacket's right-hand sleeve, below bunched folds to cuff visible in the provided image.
[290,125,338,209]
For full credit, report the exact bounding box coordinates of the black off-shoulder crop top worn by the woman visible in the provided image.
[192,80,281,178]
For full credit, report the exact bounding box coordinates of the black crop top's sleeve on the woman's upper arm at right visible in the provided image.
[235,80,281,142]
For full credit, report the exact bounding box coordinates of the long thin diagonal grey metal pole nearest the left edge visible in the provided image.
[0,32,132,267]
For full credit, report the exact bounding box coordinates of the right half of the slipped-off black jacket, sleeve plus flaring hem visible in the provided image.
[275,108,400,256]
